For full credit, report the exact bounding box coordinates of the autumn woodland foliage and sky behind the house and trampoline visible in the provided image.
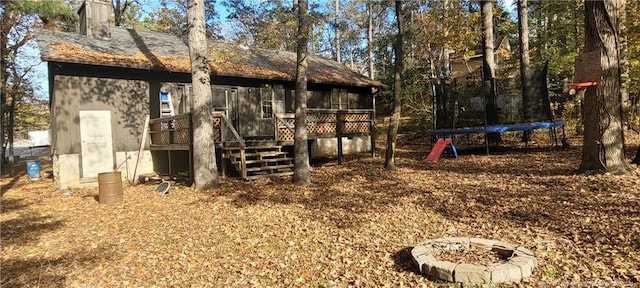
[0,0,640,160]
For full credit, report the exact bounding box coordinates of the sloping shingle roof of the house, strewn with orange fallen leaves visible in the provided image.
[35,27,384,87]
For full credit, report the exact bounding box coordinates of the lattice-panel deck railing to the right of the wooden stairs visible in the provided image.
[275,109,374,141]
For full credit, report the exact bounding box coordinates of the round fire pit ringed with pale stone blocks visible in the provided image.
[411,237,537,284]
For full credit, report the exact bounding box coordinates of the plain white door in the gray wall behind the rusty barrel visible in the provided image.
[80,111,114,178]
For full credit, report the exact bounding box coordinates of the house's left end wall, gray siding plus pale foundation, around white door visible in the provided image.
[51,75,152,189]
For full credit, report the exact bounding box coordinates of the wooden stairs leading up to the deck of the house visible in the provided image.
[222,145,293,180]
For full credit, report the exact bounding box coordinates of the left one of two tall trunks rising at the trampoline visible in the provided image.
[480,0,500,143]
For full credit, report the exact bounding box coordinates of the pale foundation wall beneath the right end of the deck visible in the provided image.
[310,136,371,158]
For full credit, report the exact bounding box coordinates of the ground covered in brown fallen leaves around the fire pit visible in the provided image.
[0,138,640,287]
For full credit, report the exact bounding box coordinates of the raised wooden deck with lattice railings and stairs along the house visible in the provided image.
[149,109,375,180]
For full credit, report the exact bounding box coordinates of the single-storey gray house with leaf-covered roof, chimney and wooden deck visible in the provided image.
[35,1,383,188]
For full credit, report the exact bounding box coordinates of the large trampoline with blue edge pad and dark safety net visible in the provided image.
[430,64,565,154]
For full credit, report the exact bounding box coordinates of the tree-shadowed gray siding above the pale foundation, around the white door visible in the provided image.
[52,75,149,155]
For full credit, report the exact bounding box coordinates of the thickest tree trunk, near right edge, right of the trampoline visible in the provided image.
[580,0,630,174]
